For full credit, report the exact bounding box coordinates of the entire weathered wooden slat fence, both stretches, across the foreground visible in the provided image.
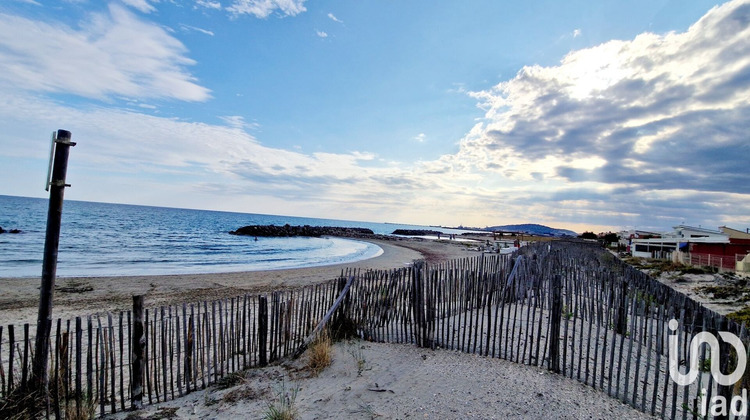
[0,241,750,418]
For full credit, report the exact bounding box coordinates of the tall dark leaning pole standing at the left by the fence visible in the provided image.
[32,130,75,394]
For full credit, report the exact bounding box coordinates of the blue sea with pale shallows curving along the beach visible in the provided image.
[0,195,476,278]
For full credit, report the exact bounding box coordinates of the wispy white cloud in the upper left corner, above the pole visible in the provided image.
[0,5,209,101]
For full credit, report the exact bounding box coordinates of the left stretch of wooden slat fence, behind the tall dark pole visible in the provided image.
[0,280,346,418]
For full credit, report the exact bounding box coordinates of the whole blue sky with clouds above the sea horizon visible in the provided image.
[0,0,750,232]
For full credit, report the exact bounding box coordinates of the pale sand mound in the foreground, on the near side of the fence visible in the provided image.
[104,340,650,419]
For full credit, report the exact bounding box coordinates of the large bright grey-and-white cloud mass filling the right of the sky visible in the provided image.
[452,1,750,230]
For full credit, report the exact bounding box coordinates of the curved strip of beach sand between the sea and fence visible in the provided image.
[0,238,477,325]
